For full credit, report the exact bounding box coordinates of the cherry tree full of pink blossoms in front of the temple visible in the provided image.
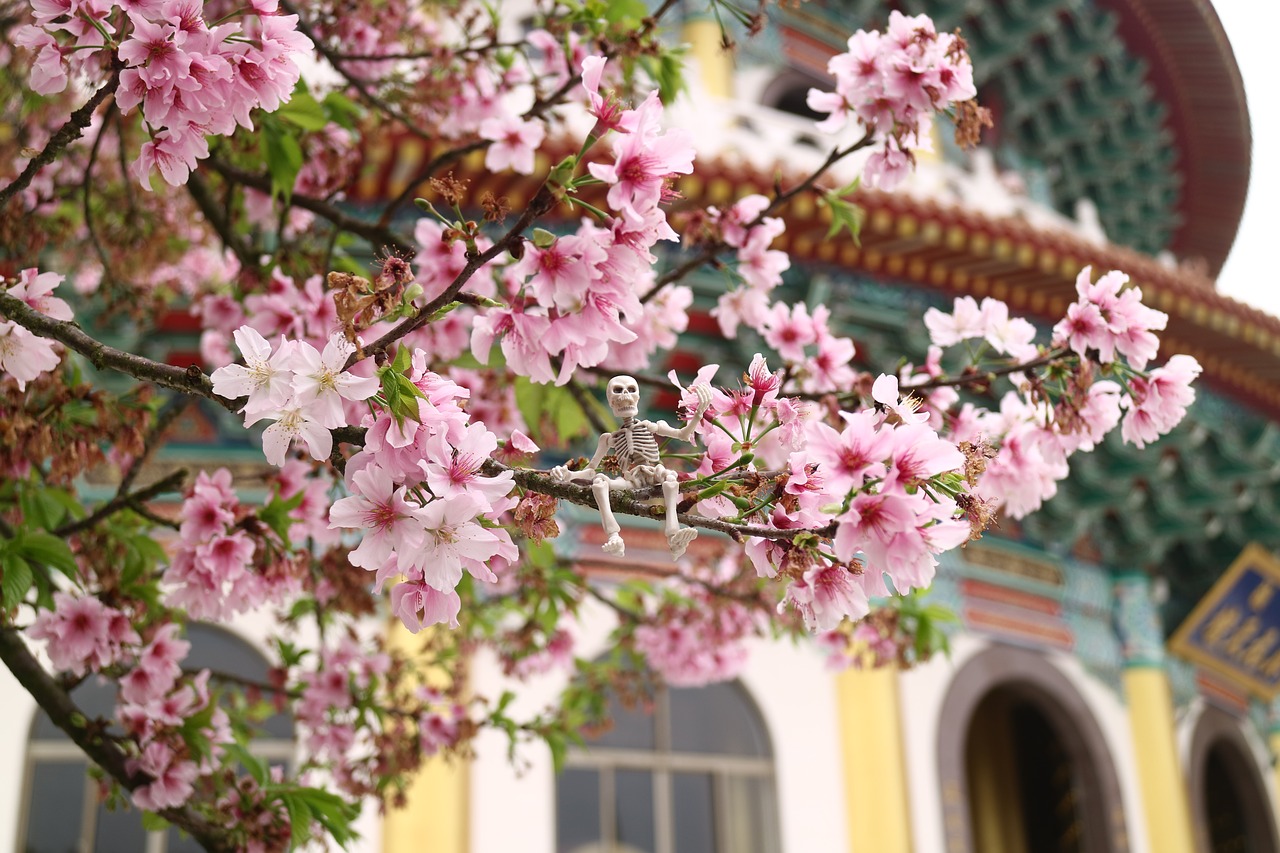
[0,0,1199,850]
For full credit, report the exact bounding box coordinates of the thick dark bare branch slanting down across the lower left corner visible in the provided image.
[0,628,236,853]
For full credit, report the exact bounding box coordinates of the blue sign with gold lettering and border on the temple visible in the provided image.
[1169,544,1280,699]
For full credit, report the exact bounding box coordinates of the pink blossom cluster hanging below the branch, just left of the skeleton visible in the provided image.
[329,350,518,631]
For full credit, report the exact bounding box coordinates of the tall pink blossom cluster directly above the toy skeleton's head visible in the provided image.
[471,56,694,384]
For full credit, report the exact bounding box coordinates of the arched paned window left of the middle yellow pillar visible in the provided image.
[556,683,781,853]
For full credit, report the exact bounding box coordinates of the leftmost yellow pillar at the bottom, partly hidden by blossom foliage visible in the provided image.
[383,620,471,853]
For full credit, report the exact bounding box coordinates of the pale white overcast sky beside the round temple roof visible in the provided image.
[1213,0,1280,315]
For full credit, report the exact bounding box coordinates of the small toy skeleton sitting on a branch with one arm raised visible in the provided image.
[550,377,712,560]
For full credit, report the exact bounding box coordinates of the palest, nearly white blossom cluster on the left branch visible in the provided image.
[211,325,379,466]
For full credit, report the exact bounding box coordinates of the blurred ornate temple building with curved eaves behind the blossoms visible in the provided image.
[0,0,1280,853]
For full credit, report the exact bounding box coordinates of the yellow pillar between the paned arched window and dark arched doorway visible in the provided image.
[836,666,911,853]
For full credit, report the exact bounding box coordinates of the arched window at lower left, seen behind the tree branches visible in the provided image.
[17,624,294,853]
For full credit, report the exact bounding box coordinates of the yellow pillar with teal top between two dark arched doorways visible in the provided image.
[1115,574,1196,853]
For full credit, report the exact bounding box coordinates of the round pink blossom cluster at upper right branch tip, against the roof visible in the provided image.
[808,10,978,190]
